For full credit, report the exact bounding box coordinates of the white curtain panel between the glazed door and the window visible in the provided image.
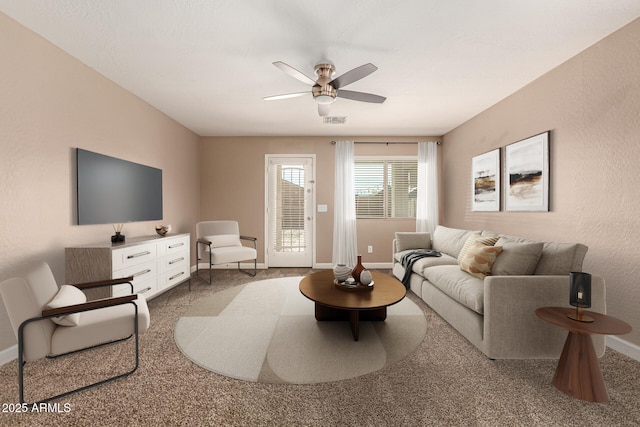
[332,141,358,268]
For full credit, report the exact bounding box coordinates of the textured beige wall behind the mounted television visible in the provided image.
[0,13,200,351]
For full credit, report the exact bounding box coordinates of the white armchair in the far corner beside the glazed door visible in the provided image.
[196,221,258,284]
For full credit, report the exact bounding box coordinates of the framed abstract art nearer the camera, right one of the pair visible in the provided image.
[504,131,549,211]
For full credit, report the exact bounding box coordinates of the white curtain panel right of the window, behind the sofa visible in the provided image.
[416,142,440,235]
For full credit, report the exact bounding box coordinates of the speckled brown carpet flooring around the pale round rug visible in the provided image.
[0,269,640,427]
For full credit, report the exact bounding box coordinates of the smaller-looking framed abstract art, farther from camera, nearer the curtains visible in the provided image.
[471,148,500,211]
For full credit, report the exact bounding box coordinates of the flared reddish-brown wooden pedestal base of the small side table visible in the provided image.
[553,332,609,402]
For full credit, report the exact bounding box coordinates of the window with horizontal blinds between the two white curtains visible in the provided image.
[354,157,418,218]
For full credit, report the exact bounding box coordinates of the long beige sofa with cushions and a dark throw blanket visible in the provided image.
[393,226,606,359]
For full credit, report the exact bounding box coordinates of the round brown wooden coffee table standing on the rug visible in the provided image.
[300,270,407,341]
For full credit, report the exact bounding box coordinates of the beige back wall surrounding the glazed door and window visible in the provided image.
[200,136,437,266]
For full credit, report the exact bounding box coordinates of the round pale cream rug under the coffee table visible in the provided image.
[175,277,426,384]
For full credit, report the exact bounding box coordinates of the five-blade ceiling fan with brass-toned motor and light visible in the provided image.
[262,61,387,116]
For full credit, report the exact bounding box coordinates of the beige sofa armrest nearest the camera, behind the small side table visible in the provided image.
[483,275,606,359]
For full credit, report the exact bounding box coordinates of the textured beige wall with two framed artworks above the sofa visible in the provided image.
[442,20,640,345]
